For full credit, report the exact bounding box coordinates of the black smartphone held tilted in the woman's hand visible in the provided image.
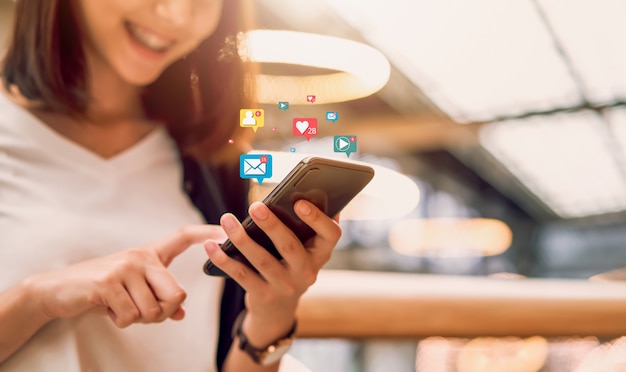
[204,157,374,276]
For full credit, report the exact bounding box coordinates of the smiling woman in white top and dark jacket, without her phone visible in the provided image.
[0,0,341,371]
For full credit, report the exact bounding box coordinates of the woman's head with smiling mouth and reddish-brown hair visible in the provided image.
[3,0,254,159]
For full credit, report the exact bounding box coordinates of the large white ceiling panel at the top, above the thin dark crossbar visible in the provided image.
[326,0,580,122]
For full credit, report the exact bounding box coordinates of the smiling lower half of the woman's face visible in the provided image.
[76,0,222,85]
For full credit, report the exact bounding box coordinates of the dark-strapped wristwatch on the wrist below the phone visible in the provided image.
[233,309,298,366]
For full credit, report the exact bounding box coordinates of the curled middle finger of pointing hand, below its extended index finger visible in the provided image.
[146,268,187,321]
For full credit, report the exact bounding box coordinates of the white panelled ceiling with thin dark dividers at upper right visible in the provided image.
[262,0,626,219]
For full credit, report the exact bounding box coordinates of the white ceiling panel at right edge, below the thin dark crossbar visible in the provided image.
[480,111,626,218]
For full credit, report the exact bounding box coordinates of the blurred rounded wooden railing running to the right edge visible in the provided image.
[298,270,626,338]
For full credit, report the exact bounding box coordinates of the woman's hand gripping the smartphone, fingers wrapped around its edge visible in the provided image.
[205,200,341,345]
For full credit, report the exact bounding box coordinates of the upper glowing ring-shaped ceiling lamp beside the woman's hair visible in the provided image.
[238,30,391,105]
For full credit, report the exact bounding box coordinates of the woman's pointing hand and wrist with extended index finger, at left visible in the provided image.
[25,225,226,328]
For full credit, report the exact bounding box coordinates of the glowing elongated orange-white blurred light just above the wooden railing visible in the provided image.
[389,218,513,256]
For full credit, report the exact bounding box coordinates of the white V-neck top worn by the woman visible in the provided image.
[0,93,223,372]
